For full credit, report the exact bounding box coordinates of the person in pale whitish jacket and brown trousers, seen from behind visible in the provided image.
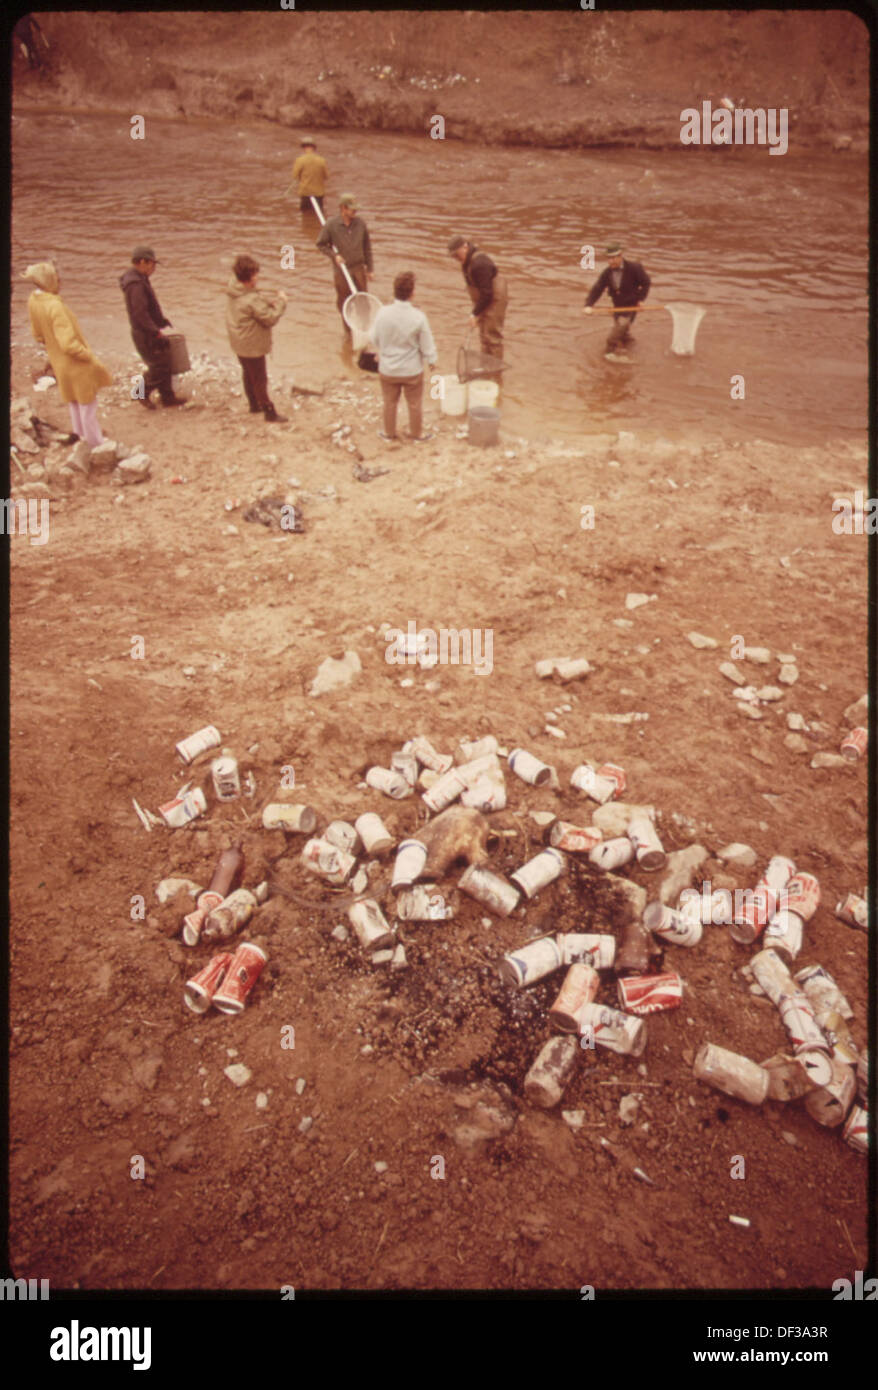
[371,270,436,443]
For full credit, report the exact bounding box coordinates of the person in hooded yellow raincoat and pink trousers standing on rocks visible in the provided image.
[21,261,113,448]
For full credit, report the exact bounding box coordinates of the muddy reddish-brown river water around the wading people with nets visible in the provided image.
[13,111,868,443]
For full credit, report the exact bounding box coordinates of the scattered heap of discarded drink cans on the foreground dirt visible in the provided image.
[147,726,868,1154]
